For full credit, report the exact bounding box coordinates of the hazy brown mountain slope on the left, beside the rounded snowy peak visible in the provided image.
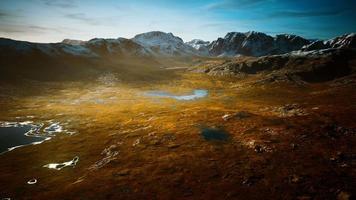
[0,38,163,81]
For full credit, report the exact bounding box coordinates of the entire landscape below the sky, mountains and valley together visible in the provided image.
[0,31,356,199]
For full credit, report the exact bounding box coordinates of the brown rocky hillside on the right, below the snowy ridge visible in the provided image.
[192,48,356,83]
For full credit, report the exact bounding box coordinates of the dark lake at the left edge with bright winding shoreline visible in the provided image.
[0,124,48,154]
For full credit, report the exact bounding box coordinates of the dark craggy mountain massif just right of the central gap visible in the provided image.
[209,31,310,57]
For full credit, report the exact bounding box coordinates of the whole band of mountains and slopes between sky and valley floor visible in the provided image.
[0,31,356,81]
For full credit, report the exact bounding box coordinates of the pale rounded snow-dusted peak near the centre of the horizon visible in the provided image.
[132,31,198,56]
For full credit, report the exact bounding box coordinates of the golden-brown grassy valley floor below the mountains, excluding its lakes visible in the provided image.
[0,70,356,199]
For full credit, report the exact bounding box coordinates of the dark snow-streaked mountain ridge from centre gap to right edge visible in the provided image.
[186,31,356,57]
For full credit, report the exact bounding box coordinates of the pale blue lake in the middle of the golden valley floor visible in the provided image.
[146,90,208,101]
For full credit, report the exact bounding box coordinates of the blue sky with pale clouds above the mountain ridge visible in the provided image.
[0,0,356,42]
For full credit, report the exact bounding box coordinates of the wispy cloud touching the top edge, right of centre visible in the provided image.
[204,0,271,10]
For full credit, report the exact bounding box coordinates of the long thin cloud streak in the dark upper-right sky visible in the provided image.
[268,9,347,18]
